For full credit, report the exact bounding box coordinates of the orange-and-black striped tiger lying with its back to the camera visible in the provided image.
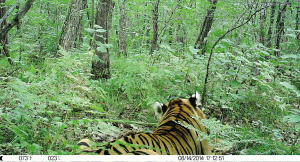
[78,91,213,155]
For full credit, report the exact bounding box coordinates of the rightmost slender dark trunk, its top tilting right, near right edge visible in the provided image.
[274,0,289,56]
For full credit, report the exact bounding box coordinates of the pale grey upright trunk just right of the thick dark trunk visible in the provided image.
[118,0,127,57]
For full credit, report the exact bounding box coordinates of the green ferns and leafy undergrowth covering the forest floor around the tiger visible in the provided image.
[0,42,300,154]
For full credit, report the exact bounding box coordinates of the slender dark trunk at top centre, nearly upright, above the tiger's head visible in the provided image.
[149,0,159,55]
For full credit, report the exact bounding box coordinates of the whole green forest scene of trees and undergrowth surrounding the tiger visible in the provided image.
[0,0,300,155]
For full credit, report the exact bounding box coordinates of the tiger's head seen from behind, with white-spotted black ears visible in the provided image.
[153,91,205,121]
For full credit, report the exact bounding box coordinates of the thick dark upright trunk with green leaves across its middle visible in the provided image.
[91,0,112,79]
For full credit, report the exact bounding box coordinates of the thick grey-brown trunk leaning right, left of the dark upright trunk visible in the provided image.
[59,0,87,51]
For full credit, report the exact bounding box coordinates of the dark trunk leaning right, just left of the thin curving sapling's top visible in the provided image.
[194,0,218,54]
